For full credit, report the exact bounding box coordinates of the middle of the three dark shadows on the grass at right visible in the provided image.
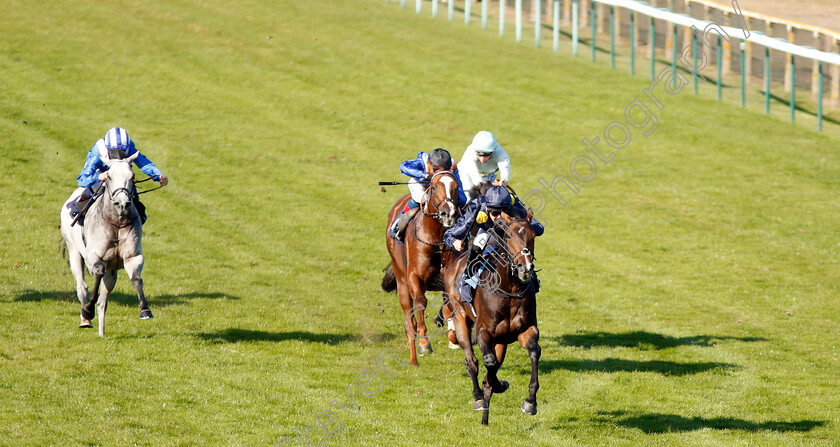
[536,358,737,376]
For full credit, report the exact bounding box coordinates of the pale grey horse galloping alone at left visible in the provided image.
[61,152,153,336]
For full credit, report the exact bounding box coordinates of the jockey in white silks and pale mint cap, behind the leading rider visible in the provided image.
[458,130,510,200]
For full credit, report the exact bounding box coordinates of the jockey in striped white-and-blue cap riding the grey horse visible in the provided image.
[67,127,169,223]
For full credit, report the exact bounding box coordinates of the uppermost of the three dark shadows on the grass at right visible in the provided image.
[546,331,766,350]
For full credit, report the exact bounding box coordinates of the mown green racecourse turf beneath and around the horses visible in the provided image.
[0,0,840,446]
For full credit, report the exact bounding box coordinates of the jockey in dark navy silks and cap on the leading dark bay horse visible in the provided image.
[443,186,545,305]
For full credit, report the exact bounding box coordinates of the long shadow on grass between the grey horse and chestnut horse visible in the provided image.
[196,328,396,345]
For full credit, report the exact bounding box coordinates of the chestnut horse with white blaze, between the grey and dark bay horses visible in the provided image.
[382,171,460,366]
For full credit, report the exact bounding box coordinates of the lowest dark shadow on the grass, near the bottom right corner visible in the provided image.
[597,411,827,433]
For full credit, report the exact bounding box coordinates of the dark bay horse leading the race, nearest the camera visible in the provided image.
[444,213,542,425]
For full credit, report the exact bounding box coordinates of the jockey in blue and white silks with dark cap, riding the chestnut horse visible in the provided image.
[391,148,467,240]
